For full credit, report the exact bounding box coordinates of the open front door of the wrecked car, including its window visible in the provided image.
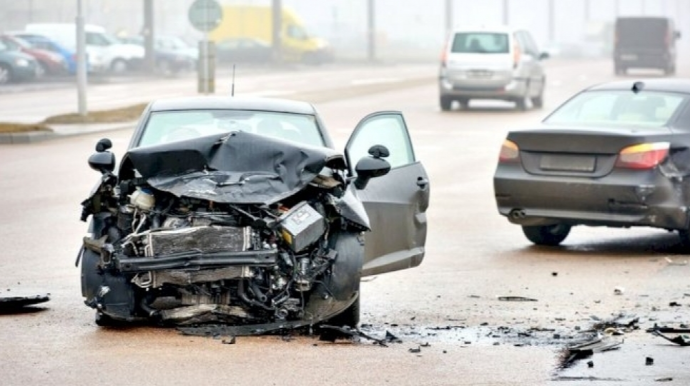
[345,111,429,276]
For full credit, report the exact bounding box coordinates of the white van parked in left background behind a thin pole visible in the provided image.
[24,23,144,73]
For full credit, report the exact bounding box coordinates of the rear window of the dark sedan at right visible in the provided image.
[544,91,685,127]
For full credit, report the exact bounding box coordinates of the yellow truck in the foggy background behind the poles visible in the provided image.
[210,5,333,64]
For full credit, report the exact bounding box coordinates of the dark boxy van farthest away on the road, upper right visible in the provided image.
[613,17,680,75]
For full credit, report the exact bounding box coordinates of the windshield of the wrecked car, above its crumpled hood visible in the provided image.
[139,110,325,146]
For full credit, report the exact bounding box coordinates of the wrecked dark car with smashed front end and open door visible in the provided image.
[77,97,429,328]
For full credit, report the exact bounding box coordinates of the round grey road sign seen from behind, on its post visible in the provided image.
[189,0,223,94]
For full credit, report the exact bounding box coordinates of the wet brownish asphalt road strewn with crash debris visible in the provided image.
[0,58,690,386]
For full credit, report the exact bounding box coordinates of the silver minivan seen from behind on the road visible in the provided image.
[439,27,548,111]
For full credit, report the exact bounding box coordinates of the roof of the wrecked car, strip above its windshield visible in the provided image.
[150,96,316,115]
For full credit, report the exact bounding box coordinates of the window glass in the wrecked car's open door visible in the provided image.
[347,114,415,168]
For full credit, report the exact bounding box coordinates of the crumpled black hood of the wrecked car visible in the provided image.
[120,132,345,205]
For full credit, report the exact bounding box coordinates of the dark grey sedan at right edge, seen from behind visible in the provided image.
[494,79,690,245]
